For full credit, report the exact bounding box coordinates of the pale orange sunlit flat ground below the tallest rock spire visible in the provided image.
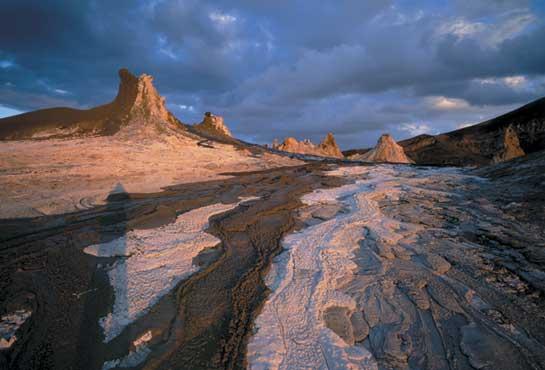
[0,137,301,218]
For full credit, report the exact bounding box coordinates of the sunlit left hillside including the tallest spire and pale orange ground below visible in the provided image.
[0,69,300,218]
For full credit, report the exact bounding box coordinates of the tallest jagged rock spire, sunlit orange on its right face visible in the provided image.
[114,68,171,121]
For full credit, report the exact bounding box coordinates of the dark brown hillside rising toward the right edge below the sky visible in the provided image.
[344,98,545,166]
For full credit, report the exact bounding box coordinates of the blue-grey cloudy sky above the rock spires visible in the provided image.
[0,0,545,149]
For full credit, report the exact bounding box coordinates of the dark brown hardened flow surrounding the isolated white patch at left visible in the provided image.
[0,165,343,369]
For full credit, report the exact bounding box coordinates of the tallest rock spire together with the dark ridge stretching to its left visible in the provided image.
[0,68,184,140]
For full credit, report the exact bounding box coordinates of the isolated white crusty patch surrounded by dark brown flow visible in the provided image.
[84,197,255,342]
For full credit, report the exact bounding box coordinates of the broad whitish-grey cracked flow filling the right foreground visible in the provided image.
[247,165,545,369]
